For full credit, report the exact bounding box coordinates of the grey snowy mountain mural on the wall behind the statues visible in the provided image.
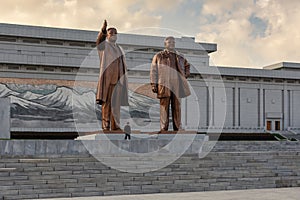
[0,83,159,128]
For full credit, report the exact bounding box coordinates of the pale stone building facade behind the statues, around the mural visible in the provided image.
[0,24,300,132]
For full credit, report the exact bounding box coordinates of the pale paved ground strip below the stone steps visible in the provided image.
[42,187,300,200]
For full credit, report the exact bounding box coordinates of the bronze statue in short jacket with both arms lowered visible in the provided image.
[150,37,191,132]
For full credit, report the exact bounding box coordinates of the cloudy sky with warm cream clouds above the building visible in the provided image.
[0,0,300,68]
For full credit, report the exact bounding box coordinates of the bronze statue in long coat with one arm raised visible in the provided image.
[96,20,128,131]
